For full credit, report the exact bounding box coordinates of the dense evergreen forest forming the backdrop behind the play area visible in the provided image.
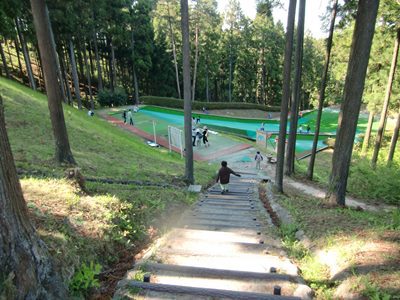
[0,0,399,112]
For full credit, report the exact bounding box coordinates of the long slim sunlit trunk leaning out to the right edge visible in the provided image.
[371,28,400,168]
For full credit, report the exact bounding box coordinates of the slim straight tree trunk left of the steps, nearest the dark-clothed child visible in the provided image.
[181,0,194,184]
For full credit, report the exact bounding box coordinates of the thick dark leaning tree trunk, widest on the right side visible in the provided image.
[326,0,379,206]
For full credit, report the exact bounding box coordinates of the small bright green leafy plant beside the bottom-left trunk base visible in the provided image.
[69,261,101,296]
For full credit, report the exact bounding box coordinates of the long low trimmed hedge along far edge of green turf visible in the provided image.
[140,96,280,112]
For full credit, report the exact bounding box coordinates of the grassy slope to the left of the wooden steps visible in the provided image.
[0,78,216,294]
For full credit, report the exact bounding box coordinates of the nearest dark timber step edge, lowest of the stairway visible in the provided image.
[120,280,301,300]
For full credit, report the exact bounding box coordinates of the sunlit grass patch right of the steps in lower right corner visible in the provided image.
[278,189,400,299]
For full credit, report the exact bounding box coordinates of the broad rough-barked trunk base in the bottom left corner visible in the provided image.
[0,96,67,299]
